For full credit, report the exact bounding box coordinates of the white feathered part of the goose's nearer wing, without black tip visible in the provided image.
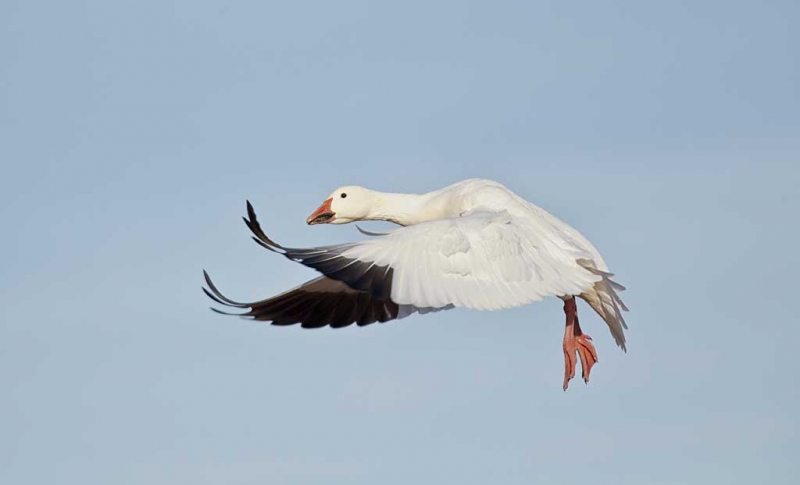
[342,210,600,310]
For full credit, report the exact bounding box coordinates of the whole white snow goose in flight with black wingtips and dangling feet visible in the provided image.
[203,179,628,390]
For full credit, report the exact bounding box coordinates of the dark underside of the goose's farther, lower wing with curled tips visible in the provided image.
[203,272,400,328]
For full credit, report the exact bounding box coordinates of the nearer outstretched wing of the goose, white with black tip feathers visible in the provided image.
[245,202,601,310]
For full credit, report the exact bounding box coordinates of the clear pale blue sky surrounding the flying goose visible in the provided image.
[0,0,800,484]
